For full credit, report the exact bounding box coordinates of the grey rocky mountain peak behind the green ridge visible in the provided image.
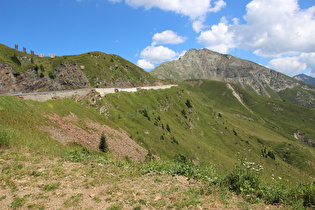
[150,49,315,108]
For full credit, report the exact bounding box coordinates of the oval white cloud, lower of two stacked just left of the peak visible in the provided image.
[140,46,178,63]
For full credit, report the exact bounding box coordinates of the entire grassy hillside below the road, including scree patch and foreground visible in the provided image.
[0,80,315,209]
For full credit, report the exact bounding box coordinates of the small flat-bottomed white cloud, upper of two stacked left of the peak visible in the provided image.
[152,30,186,45]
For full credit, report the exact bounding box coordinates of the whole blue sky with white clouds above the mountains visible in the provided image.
[0,0,315,77]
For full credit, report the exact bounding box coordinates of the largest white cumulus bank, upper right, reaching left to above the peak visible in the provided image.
[198,0,315,57]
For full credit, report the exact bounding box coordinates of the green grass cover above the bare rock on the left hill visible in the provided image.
[0,44,156,86]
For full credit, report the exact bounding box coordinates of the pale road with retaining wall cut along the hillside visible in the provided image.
[1,85,177,102]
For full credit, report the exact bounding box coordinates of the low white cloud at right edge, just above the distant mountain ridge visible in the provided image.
[268,53,315,76]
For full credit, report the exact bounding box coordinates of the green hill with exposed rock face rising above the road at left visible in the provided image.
[0,44,158,93]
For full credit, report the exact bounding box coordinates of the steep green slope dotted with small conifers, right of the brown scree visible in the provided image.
[104,81,315,183]
